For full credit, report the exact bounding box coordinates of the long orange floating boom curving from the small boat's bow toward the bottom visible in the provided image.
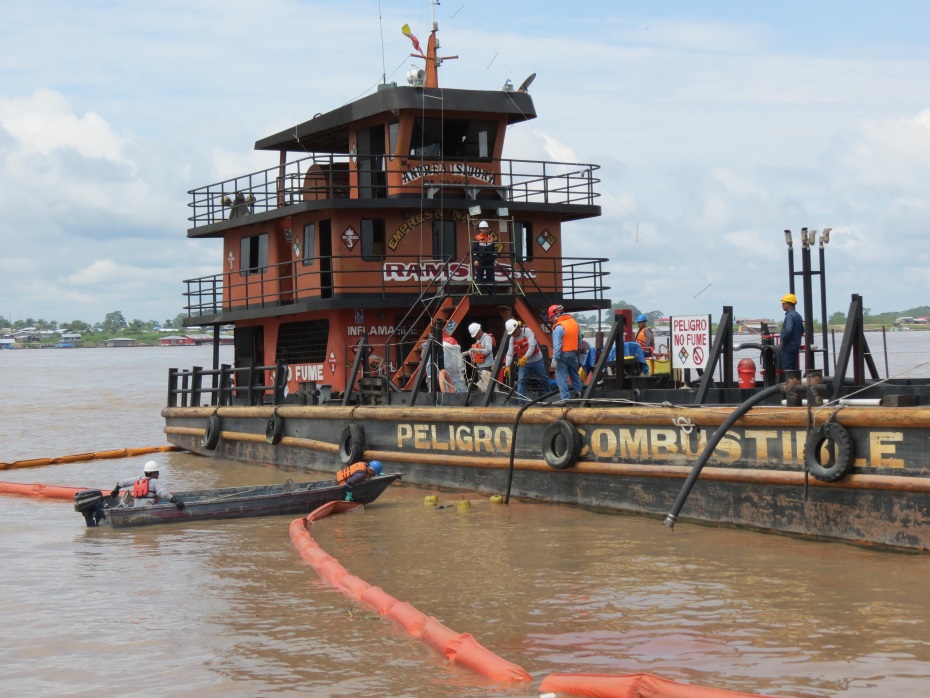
[290,502,532,683]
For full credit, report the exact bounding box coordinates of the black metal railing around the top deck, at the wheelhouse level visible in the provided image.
[188,155,600,228]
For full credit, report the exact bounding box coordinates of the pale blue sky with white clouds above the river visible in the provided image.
[0,0,930,323]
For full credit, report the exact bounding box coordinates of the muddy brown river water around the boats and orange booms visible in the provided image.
[0,332,930,698]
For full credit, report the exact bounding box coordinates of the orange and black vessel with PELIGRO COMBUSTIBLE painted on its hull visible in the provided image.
[162,4,930,550]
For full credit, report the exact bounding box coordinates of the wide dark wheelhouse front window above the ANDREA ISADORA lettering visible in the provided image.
[410,117,497,160]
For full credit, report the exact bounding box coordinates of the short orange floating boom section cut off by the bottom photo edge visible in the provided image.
[539,674,776,698]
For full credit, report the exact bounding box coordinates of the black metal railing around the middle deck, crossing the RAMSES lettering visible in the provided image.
[183,255,610,317]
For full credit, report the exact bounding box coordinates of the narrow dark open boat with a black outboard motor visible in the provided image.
[74,474,400,528]
